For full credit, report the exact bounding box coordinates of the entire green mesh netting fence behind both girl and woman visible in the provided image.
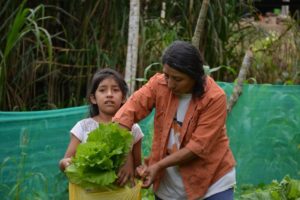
[0,83,300,199]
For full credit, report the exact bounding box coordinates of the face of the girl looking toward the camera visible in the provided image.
[90,77,125,116]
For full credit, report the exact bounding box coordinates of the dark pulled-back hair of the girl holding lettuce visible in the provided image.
[87,68,128,117]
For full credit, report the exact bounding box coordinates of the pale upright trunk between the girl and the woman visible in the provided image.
[125,0,140,95]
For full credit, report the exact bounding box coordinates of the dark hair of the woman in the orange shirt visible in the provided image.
[162,41,205,97]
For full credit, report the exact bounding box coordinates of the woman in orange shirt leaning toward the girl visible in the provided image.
[113,41,236,200]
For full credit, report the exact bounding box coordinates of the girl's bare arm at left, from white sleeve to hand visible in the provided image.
[59,134,81,171]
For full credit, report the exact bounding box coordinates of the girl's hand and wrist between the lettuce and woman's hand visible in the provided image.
[117,152,135,187]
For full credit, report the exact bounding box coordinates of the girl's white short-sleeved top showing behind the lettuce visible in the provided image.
[71,118,144,144]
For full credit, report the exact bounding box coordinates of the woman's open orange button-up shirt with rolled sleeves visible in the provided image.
[113,74,235,199]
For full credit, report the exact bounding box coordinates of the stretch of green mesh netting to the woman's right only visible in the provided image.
[220,83,300,184]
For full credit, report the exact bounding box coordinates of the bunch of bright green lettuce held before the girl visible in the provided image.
[65,123,132,189]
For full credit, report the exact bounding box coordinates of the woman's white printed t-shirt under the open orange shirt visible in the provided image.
[155,94,236,200]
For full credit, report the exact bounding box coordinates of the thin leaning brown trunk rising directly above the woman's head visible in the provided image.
[192,0,209,50]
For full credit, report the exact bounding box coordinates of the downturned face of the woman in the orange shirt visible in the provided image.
[163,64,195,95]
